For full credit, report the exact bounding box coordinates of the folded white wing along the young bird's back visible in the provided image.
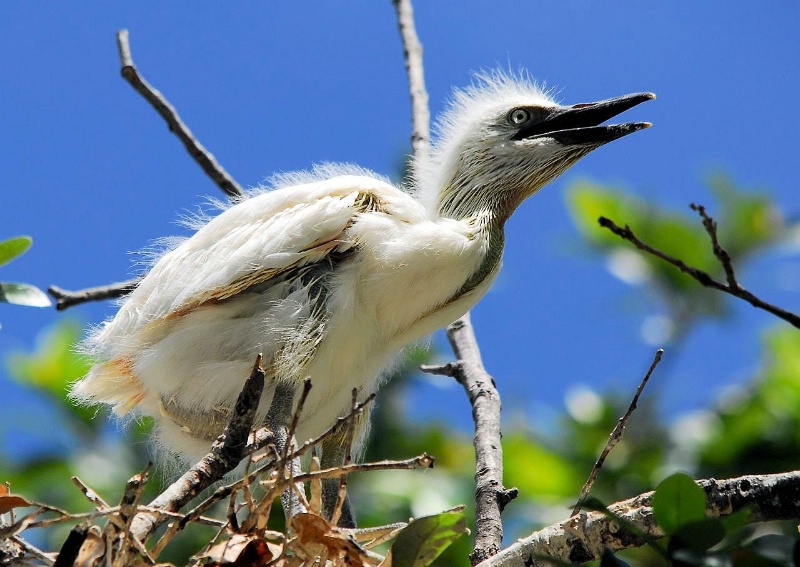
[86,176,407,360]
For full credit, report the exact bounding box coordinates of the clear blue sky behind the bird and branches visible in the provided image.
[0,0,800,442]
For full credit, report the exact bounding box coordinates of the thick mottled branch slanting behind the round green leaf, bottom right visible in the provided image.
[480,471,800,567]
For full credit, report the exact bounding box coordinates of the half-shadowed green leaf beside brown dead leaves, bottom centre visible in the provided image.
[389,506,469,567]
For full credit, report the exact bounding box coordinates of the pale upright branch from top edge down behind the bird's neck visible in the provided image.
[392,0,431,159]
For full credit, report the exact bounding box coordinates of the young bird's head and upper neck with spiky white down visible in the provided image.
[414,72,655,222]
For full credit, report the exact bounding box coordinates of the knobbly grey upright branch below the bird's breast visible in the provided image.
[438,313,518,565]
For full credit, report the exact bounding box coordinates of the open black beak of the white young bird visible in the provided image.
[512,93,656,146]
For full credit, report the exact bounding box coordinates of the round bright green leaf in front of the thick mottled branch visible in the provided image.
[653,473,706,535]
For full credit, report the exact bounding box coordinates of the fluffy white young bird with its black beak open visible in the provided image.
[72,69,654,508]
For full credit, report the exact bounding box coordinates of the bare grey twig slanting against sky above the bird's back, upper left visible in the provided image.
[117,30,244,199]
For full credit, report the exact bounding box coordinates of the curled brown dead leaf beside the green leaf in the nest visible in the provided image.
[291,513,371,567]
